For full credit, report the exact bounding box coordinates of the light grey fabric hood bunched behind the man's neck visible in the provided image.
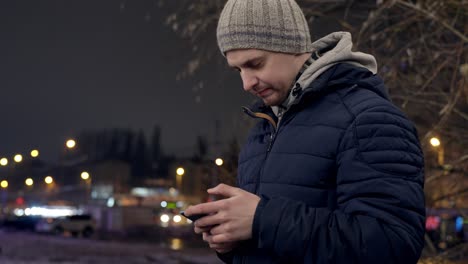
[272,32,377,117]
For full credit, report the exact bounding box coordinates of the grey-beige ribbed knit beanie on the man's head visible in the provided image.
[216,0,312,54]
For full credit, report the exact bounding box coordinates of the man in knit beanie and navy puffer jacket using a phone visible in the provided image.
[186,0,425,263]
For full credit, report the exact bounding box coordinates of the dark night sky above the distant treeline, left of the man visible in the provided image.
[0,0,253,161]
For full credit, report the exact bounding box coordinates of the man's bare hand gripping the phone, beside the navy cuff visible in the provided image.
[185,184,260,244]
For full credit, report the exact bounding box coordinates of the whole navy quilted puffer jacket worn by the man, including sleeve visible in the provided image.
[222,63,425,264]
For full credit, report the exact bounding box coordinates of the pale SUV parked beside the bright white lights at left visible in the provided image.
[36,214,96,237]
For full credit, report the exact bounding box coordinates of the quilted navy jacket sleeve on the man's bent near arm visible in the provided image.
[253,106,425,263]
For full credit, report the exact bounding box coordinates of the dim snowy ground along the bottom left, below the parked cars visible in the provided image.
[0,230,221,264]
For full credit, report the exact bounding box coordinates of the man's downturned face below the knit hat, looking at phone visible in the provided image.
[226,49,302,106]
